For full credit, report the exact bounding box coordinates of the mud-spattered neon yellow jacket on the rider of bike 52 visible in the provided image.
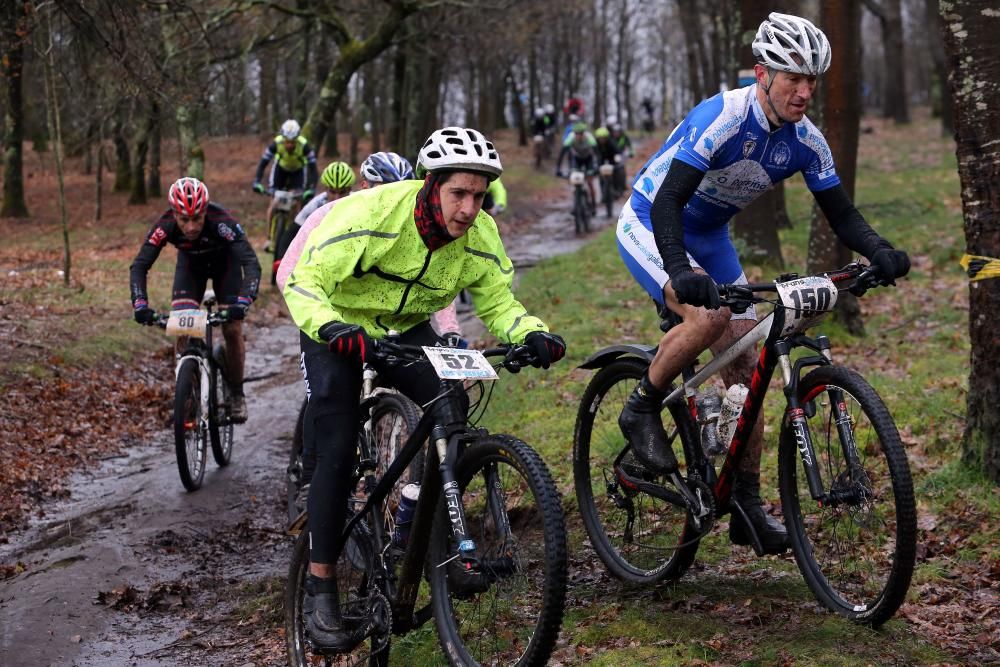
[283,180,548,343]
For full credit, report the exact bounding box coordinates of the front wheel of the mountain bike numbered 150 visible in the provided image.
[778,366,916,627]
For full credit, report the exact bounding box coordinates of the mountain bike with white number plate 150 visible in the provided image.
[573,263,916,626]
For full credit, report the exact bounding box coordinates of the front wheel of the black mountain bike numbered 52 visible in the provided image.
[429,435,567,665]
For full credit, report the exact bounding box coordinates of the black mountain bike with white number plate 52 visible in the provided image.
[285,337,567,667]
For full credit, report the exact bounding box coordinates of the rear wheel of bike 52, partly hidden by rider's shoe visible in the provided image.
[285,522,392,667]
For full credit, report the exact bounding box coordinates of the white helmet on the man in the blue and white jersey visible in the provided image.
[752,12,830,76]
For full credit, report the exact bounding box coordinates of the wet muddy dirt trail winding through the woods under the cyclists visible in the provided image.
[0,197,616,667]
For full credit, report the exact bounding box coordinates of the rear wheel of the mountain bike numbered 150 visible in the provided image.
[573,357,698,584]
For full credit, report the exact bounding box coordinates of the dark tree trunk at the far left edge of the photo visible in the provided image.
[0,0,29,218]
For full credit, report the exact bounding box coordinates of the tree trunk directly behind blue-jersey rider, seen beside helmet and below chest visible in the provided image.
[730,0,788,268]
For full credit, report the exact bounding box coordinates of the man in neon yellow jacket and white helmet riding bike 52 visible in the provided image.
[284,127,566,651]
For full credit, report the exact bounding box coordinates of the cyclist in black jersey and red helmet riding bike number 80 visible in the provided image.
[129,178,260,423]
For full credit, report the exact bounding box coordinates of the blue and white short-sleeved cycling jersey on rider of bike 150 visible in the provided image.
[630,84,840,232]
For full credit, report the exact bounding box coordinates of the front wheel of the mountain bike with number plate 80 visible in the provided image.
[174,359,208,491]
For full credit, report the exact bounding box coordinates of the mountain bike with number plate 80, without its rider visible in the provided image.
[153,290,233,491]
